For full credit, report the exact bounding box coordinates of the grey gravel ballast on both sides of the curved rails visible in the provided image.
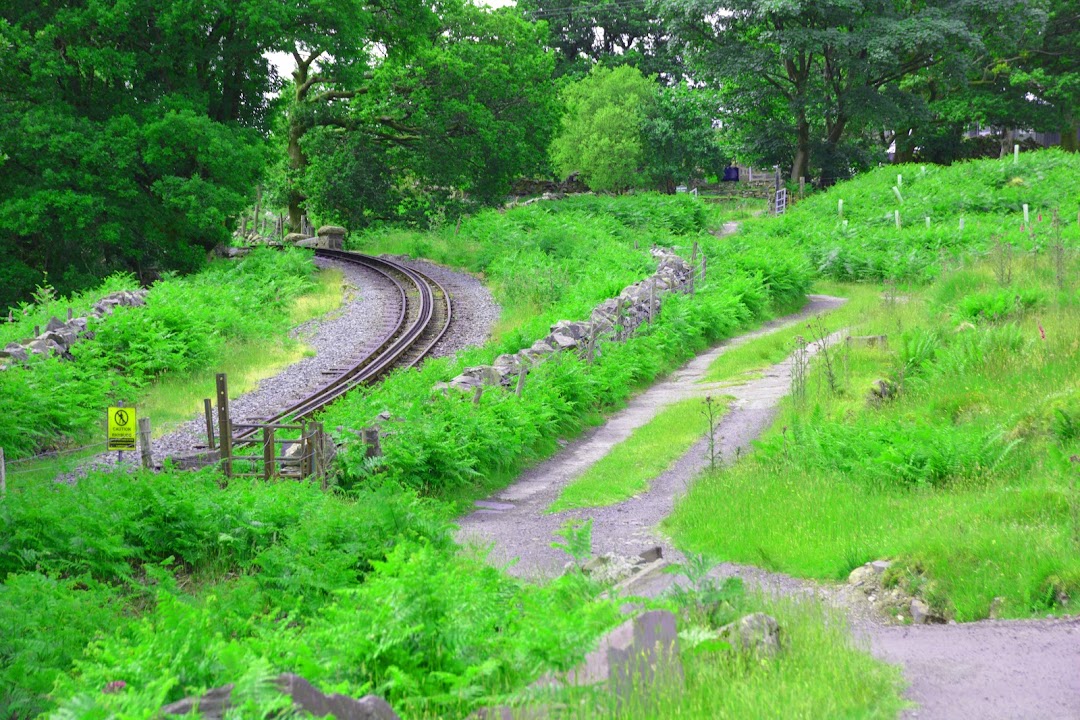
[64,252,500,472]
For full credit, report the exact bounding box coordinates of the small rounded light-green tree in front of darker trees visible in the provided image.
[552,65,658,191]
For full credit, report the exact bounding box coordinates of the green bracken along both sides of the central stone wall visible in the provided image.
[325,195,809,505]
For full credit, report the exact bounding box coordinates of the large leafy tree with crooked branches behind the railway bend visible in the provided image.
[302,2,559,228]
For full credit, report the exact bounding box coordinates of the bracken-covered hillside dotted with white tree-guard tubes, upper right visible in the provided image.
[742,150,1080,283]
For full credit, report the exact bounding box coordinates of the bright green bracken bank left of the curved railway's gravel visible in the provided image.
[0,249,314,459]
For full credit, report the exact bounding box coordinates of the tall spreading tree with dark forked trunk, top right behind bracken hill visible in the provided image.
[663,0,1027,179]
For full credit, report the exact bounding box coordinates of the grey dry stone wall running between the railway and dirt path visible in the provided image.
[442,248,696,390]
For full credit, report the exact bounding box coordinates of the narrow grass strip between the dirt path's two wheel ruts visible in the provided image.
[548,397,721,513]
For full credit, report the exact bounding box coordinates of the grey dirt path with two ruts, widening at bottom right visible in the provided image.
[459,296,1080,720]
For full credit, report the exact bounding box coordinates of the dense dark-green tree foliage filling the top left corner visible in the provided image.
[0,0,273,304]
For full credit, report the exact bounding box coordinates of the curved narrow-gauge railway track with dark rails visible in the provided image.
[234,249,453,441]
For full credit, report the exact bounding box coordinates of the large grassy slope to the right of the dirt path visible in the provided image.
[666,266,1080,621]
